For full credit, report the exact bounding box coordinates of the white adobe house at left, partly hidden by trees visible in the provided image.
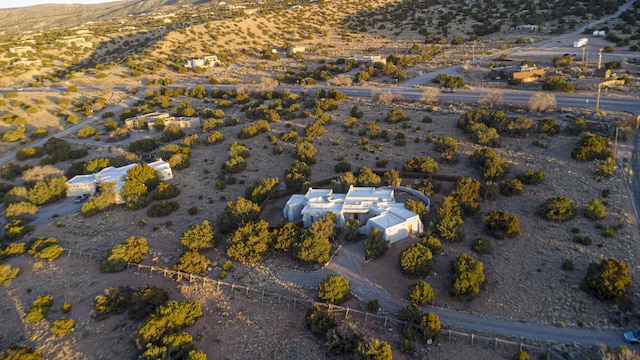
[66,160,173,200]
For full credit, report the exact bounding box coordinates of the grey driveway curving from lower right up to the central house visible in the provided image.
[276,241,625,348]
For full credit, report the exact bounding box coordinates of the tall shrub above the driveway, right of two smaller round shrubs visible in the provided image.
[449,253,485,301]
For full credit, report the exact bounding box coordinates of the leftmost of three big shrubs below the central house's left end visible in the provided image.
[227,220,272,264]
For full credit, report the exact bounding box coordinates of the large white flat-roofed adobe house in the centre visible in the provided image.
[283,186,424,243]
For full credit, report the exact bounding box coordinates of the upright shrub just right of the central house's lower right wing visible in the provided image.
[429,196,464,241]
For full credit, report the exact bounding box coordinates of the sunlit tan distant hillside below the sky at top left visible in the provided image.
[0,0,210,34]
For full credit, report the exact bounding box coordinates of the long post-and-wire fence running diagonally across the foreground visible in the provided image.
[65,249,565,360]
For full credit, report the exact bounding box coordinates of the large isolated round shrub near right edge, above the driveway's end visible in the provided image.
[582,259,631,300]
